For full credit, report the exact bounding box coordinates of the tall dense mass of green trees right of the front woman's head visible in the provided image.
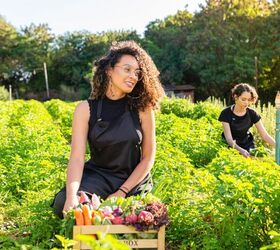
[145,0,279,99]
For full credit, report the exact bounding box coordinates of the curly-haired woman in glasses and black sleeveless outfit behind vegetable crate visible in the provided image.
[53,41,164,218]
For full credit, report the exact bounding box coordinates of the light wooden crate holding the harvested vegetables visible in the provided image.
[73,225,165,250]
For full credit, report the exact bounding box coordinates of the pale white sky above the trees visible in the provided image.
[0,0,205,35]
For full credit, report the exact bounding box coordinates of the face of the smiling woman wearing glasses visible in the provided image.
[108,55,142,96]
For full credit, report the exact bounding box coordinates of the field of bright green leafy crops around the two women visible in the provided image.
[0,99,280,250]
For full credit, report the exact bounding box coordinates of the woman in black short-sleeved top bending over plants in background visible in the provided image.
[219,83,275,157]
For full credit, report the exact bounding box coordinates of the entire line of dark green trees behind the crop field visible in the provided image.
[0,0,280,102]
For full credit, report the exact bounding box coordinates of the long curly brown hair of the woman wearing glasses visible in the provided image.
[90,41,165,111]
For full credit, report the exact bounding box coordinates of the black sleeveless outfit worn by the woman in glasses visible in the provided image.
[80,97,152,199]
